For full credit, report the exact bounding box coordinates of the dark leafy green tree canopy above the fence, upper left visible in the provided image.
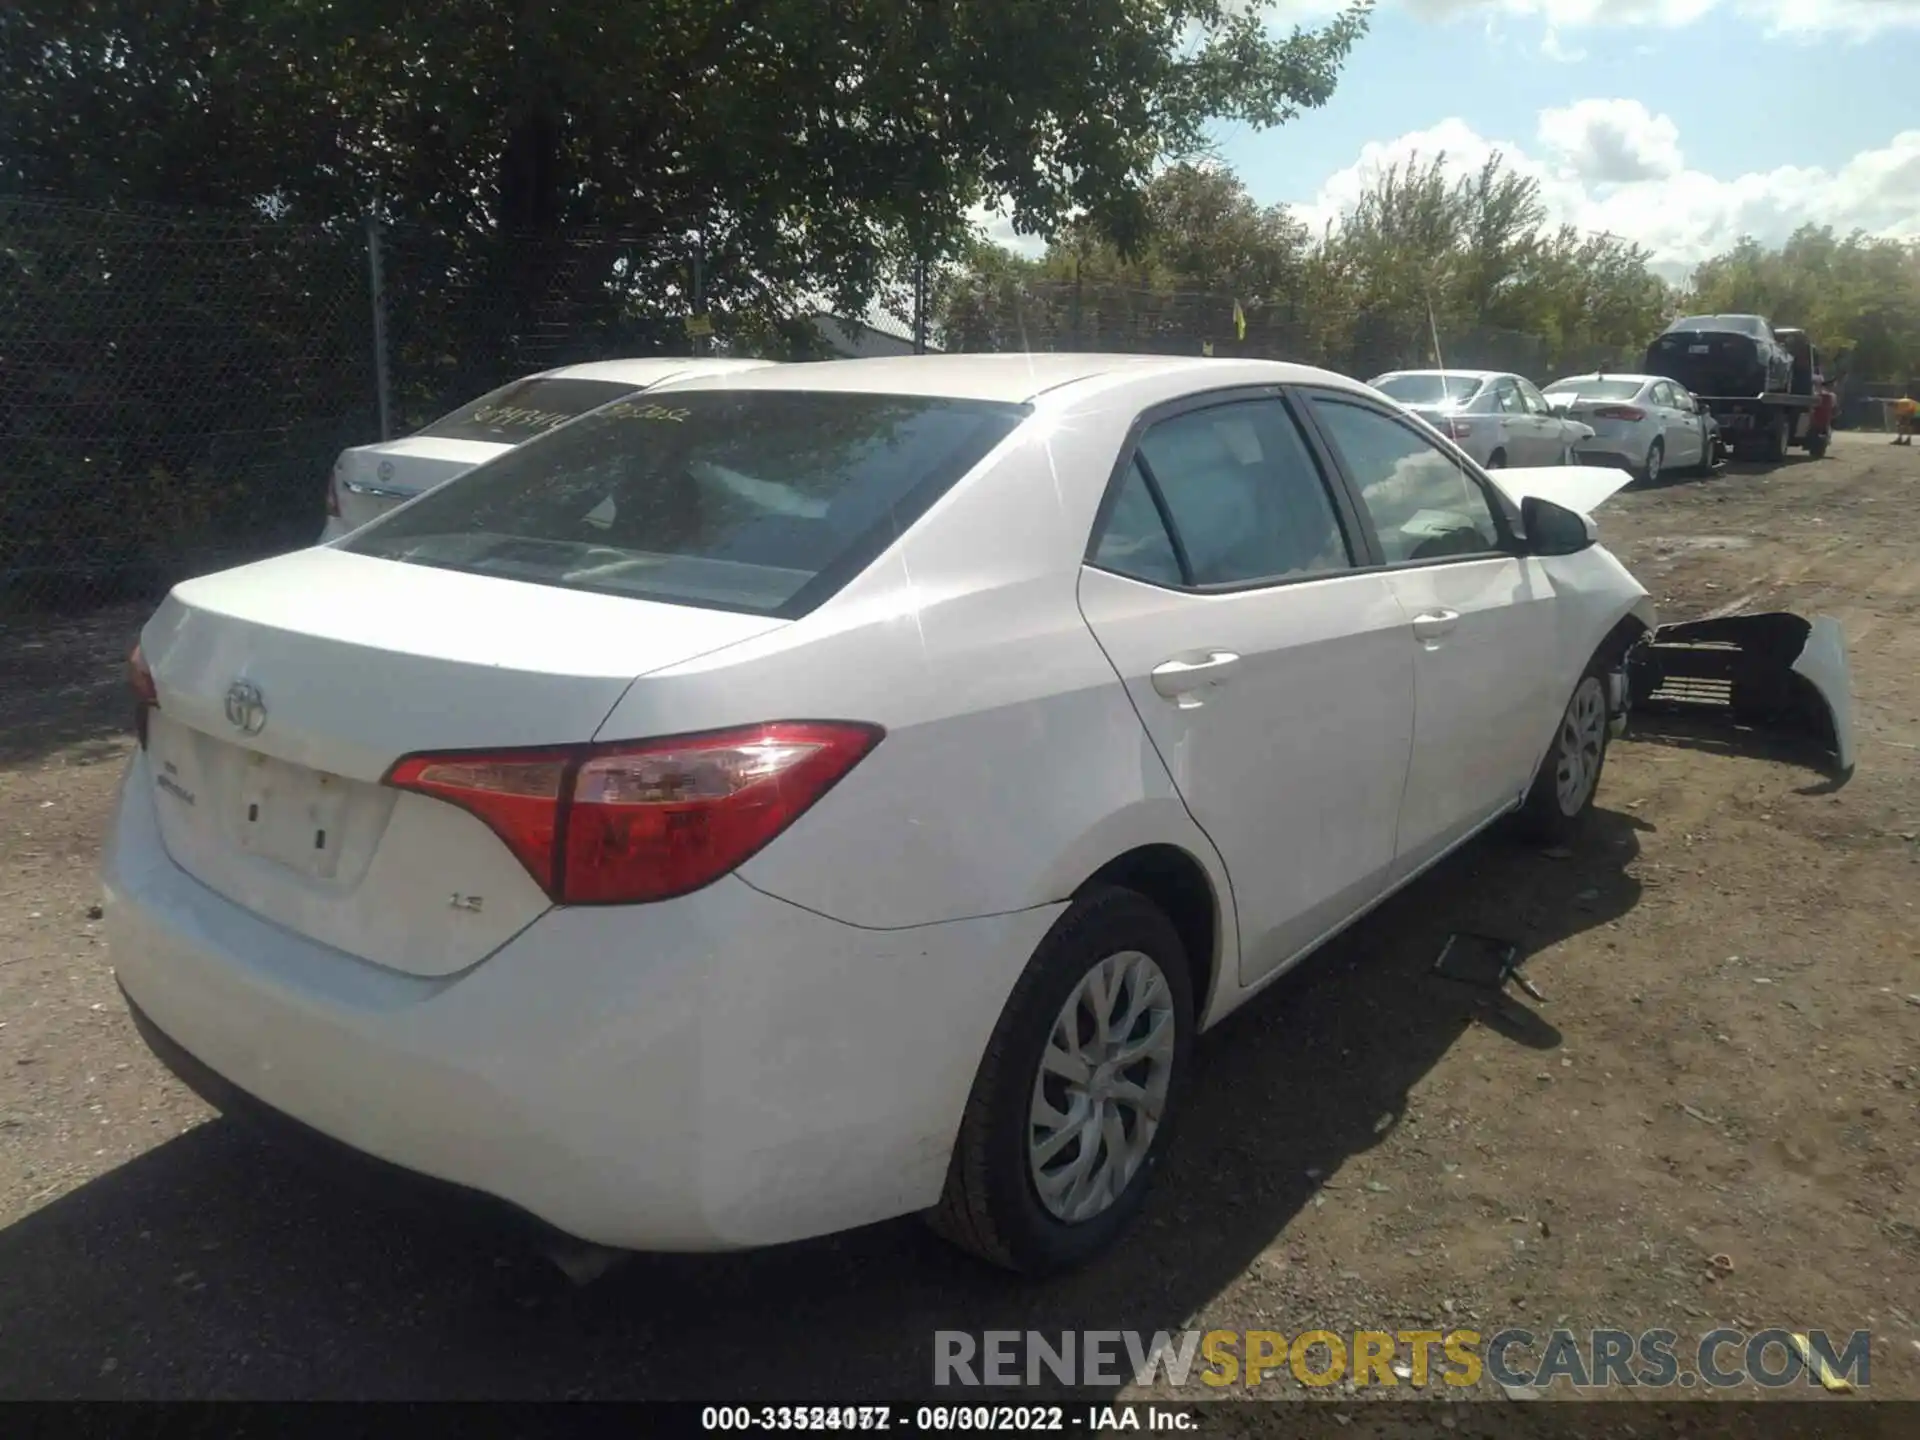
[0,0,1371,316]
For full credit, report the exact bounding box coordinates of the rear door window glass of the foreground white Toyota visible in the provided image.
[1140,399,1352,586]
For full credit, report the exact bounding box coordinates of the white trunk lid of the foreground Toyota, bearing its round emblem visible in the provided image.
[140,549,785,975]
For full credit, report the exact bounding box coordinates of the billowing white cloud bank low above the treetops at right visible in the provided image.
[1296,109,1920,280]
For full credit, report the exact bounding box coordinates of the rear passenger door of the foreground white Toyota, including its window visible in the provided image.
[1079,392,1415,983]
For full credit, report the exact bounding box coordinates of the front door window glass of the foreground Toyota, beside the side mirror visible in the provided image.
[1313,396,1500,564]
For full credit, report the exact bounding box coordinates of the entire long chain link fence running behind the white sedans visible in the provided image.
[22,196,1889,609]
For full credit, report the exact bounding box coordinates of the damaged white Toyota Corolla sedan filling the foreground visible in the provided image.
[104,355,1653,1271]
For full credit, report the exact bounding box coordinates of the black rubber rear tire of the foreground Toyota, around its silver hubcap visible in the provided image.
[927,887,1194,1275]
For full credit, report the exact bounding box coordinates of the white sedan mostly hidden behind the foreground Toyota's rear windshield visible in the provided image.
[321,359,772,543]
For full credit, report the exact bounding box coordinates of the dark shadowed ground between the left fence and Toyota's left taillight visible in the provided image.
[0,603,152,766]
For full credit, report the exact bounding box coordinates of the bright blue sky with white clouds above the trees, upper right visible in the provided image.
[987,0,1920,282]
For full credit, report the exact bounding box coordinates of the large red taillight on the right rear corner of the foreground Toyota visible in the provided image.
[386,720,881,904]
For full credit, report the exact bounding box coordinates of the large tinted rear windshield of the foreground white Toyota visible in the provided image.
[344,390,1027,618]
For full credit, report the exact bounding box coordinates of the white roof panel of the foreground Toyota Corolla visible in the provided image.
[652,351,1356,405]
